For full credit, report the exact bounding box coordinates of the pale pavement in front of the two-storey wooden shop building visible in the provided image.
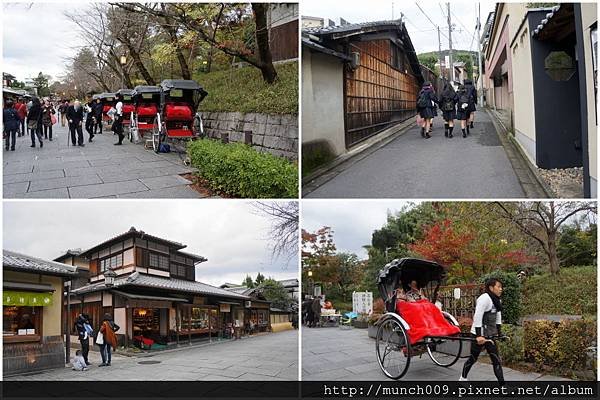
[4,330,299,381]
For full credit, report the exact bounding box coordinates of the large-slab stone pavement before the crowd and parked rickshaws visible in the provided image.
[3,124,206,198]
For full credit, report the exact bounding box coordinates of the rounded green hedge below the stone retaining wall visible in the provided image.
[188,139,298,198]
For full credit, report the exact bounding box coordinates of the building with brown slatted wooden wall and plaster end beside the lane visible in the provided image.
[302,20,423,164]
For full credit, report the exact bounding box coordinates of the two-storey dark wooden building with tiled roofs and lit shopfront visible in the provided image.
[61,228,251,345]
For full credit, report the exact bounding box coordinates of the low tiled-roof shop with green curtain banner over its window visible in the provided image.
[2,250,77,375]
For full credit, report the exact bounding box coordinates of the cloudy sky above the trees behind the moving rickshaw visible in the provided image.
[302,199,418,258]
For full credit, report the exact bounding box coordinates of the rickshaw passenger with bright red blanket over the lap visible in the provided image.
[396,280,460,344]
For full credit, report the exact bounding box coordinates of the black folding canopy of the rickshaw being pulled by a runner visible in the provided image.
[377,258,446,310]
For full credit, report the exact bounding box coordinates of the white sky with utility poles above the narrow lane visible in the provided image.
[300,0,495,53]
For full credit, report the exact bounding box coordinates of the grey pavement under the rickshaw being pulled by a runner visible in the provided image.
[302,327,568,381]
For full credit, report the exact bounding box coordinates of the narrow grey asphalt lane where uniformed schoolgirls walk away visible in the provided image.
[303,111,525,198]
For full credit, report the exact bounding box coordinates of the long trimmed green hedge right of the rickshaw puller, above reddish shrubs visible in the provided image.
[520,266,598,317]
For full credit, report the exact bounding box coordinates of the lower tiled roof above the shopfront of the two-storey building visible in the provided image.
[72,272,248,300]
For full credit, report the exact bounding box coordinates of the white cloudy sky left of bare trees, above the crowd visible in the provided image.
[2,2,88,81]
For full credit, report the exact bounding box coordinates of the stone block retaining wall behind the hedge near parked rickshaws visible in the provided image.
[202,112,298,160]
